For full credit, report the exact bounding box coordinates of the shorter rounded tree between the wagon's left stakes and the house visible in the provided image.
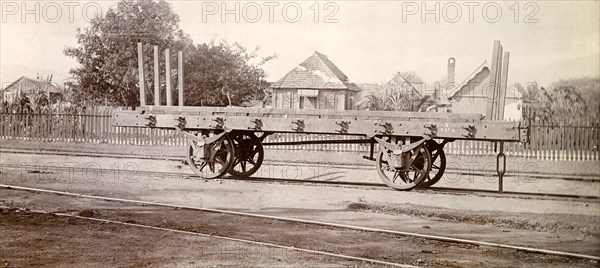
[184,42,276,106]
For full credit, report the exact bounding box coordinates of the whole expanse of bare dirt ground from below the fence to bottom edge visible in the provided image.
[0,143,600,267]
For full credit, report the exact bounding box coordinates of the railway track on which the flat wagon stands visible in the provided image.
[0,161,600,202]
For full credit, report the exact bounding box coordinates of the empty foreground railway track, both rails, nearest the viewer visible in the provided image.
[0,184,600,262]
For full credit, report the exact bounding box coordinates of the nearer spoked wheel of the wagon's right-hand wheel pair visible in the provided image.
[376,140,431,191]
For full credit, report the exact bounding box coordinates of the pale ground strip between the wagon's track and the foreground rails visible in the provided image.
[0,164,600,255]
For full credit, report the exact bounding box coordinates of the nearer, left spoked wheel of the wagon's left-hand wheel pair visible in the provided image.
[188,133,235,179]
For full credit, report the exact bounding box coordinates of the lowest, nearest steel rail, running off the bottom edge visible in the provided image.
[14,210,418,268]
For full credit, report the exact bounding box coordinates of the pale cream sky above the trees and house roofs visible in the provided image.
[0,0,600,88]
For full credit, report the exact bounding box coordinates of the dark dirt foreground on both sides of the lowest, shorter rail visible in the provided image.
[0,189,597,267]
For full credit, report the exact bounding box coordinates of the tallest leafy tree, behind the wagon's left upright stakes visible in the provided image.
[64,0,192,106]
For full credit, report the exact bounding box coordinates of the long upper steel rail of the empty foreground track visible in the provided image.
[0,184,600,261]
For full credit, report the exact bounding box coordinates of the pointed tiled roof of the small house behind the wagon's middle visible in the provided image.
[271,51,360,91]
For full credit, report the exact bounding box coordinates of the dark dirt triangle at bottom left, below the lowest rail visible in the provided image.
[0,205,356,267]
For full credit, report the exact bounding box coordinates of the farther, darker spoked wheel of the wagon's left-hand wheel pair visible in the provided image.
[228,131,265,177]
